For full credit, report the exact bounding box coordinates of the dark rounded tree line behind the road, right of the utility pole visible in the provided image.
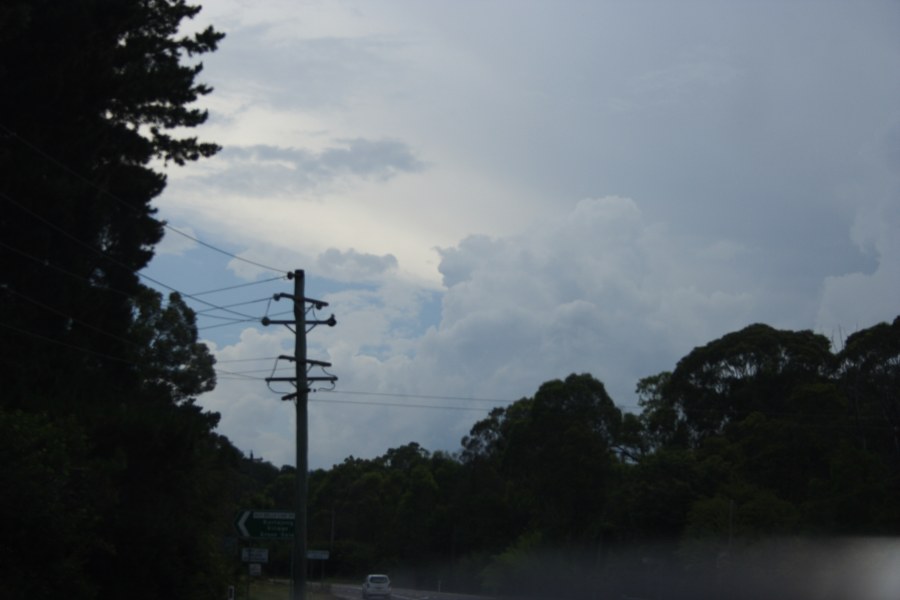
[241,317,900,597]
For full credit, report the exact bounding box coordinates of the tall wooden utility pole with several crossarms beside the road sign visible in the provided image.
[262,269,337,600]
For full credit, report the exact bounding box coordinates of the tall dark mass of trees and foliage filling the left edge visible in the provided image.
[0,0,240,600]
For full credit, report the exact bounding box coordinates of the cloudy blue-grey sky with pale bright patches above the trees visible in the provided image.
[144,0,900,469]
